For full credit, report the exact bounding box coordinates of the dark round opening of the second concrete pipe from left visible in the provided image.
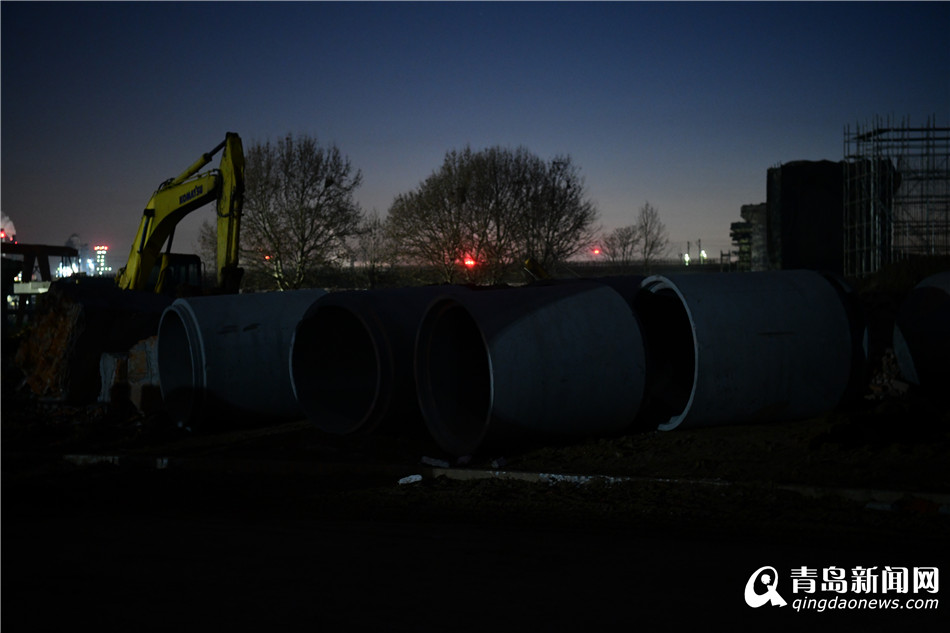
[291,305,383,434]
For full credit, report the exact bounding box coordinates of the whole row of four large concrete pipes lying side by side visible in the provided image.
[159,271,864,456]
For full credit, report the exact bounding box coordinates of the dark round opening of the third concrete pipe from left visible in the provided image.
[416,299,492,455]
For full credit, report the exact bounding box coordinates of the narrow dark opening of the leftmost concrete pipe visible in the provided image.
[157,309,204,422]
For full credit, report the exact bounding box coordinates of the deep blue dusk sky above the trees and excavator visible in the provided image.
[0,1,950,267]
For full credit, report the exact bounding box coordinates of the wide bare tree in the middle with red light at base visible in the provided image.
[387,147,596,283]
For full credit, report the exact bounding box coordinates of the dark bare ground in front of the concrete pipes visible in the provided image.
[0,368,950,631]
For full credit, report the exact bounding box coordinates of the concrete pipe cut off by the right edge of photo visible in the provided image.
[893,271,950,399]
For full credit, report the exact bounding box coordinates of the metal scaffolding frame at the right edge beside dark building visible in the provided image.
[843,117,950,277]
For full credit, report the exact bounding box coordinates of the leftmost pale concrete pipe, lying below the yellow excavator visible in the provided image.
[158,290,326,427]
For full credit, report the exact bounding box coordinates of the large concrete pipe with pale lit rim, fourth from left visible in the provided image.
[636,270,862,430]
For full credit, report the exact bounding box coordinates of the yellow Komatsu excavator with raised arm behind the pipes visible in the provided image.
[116,132,244,296]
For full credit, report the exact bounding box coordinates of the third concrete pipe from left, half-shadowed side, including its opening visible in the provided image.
[416,281,645,456]
